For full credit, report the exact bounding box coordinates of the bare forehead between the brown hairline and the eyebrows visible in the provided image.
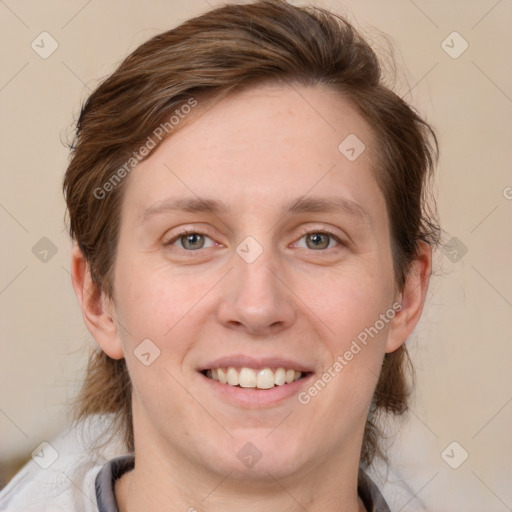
[120,84,384,226]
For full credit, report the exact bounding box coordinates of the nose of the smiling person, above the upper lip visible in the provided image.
[217,244,297,336]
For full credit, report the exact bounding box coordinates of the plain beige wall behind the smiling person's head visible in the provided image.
[0,0,512,512]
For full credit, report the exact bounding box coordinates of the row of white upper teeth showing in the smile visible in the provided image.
[206,366,302,389]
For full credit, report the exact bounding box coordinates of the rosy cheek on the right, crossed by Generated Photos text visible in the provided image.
[294,264,394,412]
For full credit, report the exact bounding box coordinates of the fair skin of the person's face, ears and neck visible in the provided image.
[72,85,431,512]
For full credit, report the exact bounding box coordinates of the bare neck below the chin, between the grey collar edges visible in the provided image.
[115,442,366,512]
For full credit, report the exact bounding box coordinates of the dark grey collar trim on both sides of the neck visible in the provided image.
[95,454,391,512]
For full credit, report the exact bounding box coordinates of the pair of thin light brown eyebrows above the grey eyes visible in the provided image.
[140,196,371,224]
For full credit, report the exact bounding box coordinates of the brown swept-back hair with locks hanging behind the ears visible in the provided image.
[63,0,440,466]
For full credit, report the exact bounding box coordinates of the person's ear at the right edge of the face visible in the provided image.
[386,241,432,352]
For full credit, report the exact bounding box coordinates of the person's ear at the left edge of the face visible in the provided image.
[71,243,124,359]
